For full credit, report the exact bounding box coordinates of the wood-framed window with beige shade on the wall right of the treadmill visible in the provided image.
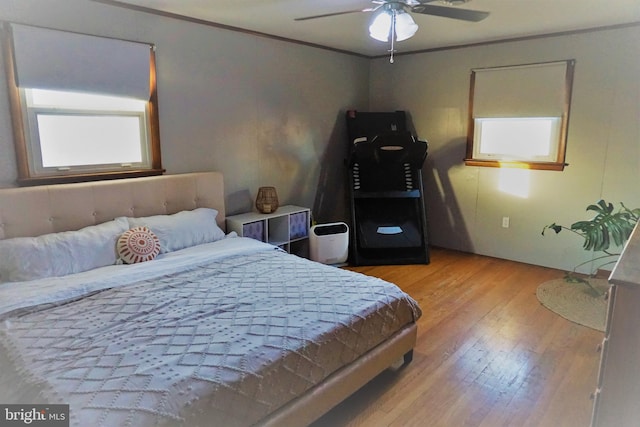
[465,61,574,170]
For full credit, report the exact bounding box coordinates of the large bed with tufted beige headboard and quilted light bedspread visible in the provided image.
[0,172,421,427]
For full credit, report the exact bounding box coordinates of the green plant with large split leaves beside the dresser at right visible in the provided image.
[542,200,640,292]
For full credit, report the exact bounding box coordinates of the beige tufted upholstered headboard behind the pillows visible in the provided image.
[0,172,225,239]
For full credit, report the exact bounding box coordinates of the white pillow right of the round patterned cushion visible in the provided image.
[128,208,224,253]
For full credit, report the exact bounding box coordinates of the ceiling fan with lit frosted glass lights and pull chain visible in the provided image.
[295,0,489,63]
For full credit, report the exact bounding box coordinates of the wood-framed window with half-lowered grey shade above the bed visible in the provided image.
[7,24,163,185]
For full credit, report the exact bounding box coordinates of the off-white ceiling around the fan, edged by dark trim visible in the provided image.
[97,0,640,57]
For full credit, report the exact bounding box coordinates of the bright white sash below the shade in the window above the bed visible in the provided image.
[21,89,150,175]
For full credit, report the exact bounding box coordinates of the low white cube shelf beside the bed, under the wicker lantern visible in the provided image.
[227,205,311,252]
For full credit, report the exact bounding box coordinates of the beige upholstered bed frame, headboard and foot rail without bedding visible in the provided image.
[0,172,417,427]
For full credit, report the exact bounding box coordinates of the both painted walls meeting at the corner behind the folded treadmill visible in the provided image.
[0,0,640,269]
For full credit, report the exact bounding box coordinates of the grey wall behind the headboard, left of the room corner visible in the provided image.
[0,0,369,219]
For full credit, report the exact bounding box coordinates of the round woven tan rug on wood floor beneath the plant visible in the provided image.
[536,279,609,331]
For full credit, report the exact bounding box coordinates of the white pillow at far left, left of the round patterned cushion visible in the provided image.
[0,217,129,282]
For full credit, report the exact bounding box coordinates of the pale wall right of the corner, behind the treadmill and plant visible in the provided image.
[370,26,640,269]
